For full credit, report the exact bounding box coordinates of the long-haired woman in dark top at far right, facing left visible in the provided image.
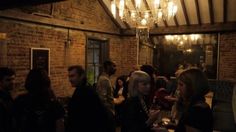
[175,69,213,132]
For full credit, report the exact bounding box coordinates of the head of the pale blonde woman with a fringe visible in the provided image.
[129,71,151,97]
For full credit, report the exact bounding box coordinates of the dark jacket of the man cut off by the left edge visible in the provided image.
[0,90,14,132]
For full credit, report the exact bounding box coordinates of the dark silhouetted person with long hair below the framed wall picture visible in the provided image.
[14,69,65,132]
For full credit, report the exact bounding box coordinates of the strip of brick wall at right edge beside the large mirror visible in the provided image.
[219,32,236,82]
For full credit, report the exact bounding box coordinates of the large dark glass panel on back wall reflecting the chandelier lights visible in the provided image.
[152,34,218,79]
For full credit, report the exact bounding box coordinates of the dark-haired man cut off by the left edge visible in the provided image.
[0,67,15,132]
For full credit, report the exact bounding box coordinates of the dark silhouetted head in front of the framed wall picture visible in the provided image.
[25,69,54,98]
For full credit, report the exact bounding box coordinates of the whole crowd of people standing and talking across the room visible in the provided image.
[0,61,213,132]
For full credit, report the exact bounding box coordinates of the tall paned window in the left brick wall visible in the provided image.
[86,38,109,85]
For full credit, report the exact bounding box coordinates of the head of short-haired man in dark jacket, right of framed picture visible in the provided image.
[68,65,87,87]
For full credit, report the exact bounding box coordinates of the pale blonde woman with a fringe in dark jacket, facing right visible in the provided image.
[122,71,159,132]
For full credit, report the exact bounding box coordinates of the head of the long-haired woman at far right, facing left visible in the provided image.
[178,68,209,101]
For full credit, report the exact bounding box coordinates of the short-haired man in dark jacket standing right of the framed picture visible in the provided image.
[67,66,114,132]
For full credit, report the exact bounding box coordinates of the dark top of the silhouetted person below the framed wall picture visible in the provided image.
[14,94,65,132]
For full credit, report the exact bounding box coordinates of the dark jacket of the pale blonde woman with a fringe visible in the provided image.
[122,97,151,132]
